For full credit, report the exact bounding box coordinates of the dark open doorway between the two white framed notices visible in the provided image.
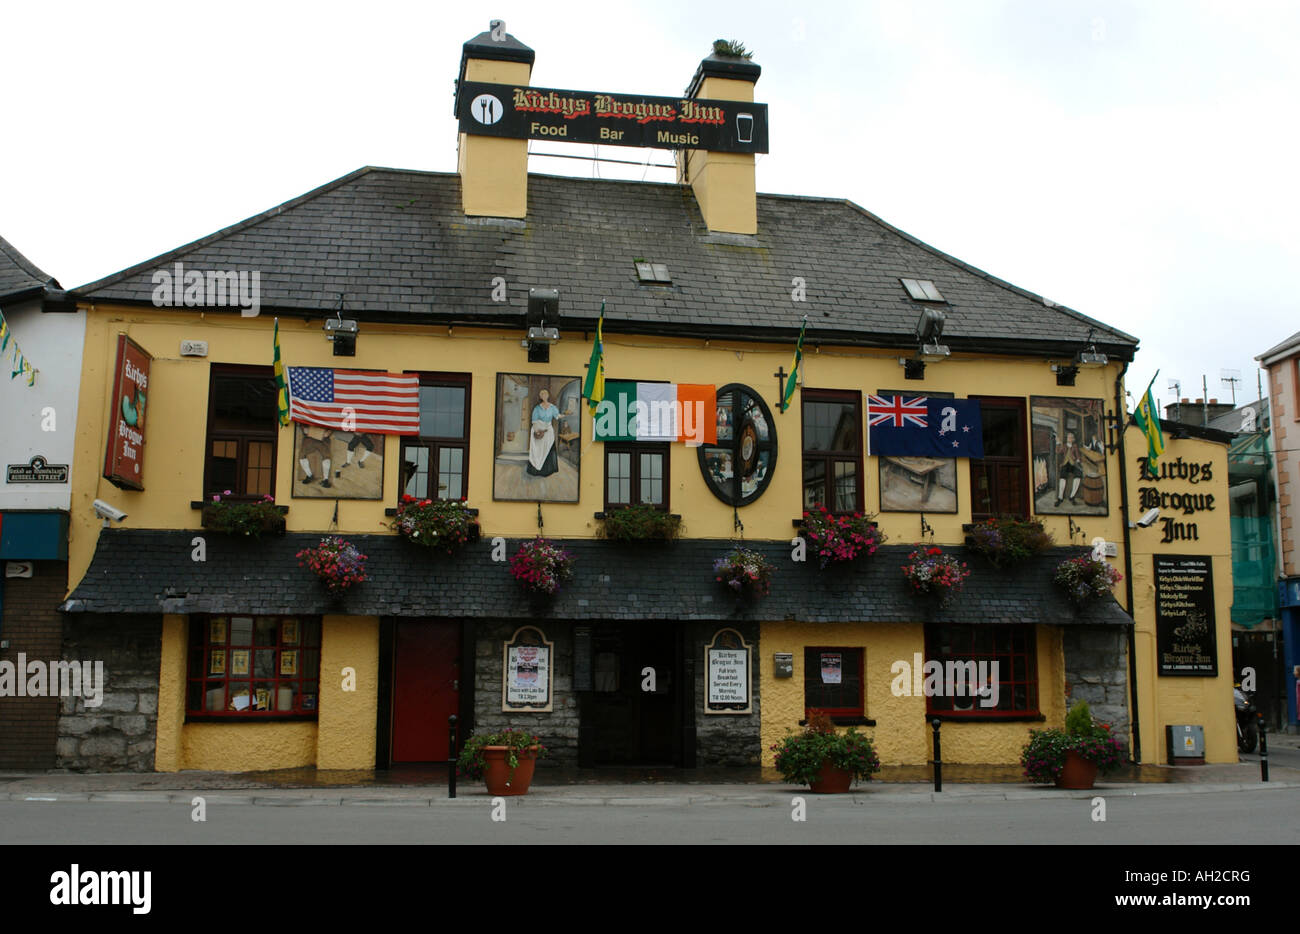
[580,620,685,766]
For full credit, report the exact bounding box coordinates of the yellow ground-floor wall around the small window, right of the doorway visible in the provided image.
[759,622,1065,766]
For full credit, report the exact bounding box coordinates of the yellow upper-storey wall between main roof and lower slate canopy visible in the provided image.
[69,303,1122,585]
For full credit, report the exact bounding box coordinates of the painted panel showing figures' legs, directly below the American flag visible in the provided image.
[293,421,385,500]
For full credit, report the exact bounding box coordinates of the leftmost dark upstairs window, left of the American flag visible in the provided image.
[203,366,278,500]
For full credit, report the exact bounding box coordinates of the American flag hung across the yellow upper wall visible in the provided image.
[287,367,420,434]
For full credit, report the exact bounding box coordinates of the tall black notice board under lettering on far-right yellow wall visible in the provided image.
[1152,554,1218,678]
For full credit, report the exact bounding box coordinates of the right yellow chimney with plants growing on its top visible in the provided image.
[677,52,762,234]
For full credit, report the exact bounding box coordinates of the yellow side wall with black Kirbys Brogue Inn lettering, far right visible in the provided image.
[1117,428,1238,764]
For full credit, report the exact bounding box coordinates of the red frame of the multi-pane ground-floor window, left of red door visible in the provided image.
[183,613,324,723]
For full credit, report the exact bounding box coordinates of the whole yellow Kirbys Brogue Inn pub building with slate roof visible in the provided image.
[48,33,1235,779]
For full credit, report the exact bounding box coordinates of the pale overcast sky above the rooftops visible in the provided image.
[0,0,1300,403]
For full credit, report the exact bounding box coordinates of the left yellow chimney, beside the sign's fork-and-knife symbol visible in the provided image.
[456,21,536,217]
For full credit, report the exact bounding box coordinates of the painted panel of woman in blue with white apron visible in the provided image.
[491,373,582,502]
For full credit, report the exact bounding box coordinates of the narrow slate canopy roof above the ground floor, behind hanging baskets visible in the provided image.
[64,529,1132,624]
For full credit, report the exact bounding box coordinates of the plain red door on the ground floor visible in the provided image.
[393,619,460,762]
